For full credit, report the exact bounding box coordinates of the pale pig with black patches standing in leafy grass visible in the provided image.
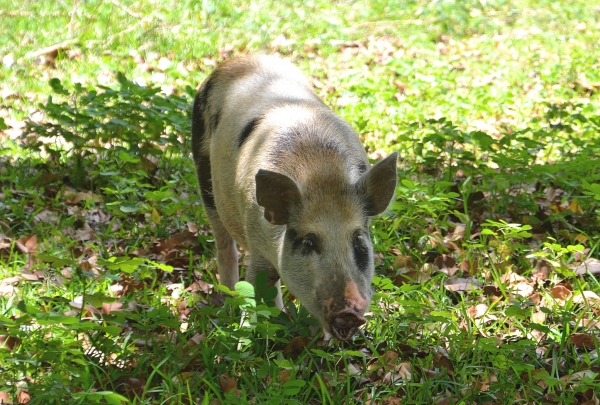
[192,55,397,341]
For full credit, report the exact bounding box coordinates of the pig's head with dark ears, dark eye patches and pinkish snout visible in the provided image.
[256,153,398,340]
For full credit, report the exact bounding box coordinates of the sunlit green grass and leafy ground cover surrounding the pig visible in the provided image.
[0,0,600,404]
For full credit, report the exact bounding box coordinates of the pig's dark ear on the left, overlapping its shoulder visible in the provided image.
[255,169,300,225]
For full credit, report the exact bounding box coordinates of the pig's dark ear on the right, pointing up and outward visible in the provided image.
[356,152,398,217]
